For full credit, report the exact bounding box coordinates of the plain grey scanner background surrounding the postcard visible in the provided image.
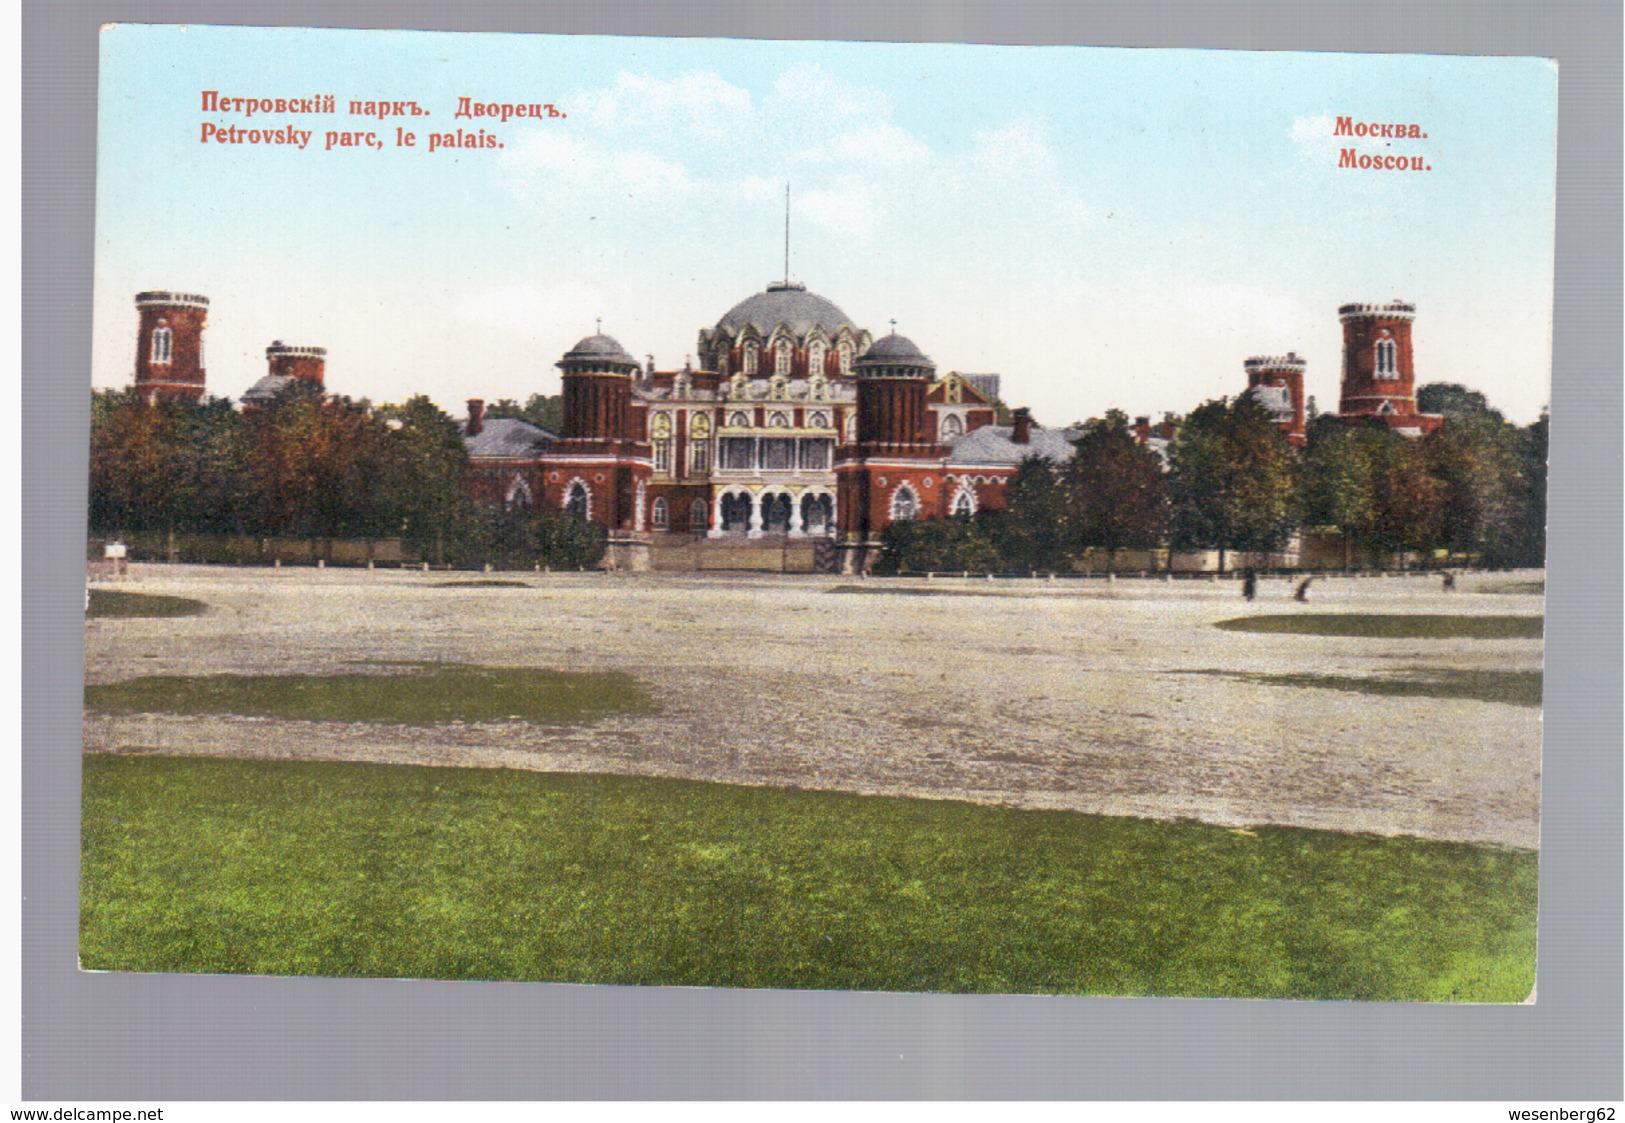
[21,0,1622,1102]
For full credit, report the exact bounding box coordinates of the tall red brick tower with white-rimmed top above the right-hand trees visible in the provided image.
[1337,301,1441,436]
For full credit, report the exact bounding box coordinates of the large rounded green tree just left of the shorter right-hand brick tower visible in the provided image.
[1168,393,1298,570]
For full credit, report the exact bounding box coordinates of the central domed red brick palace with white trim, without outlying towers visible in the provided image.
[465,281,1074,572]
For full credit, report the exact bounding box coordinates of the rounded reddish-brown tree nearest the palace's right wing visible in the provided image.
[1061,410,1168,567]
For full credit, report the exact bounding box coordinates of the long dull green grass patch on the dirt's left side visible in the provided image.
[85,663,657,725]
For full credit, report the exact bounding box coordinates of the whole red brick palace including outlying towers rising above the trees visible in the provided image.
[123,280,1443,574]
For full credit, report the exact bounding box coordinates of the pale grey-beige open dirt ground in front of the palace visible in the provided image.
[85,566,1542,847]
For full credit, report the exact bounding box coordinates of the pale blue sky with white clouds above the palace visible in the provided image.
[93,24,1557,424]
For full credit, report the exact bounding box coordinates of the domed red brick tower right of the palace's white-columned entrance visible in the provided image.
[835,332,947,574]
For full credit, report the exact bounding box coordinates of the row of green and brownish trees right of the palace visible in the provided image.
[881,384,1547,570]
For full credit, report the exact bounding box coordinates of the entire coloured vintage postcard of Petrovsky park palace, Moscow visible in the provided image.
[80,24,1557,1003]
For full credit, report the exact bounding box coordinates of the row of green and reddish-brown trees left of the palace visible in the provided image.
[89,382,605,567]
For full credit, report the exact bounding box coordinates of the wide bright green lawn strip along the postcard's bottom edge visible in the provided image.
[80,756,1537,1003]
